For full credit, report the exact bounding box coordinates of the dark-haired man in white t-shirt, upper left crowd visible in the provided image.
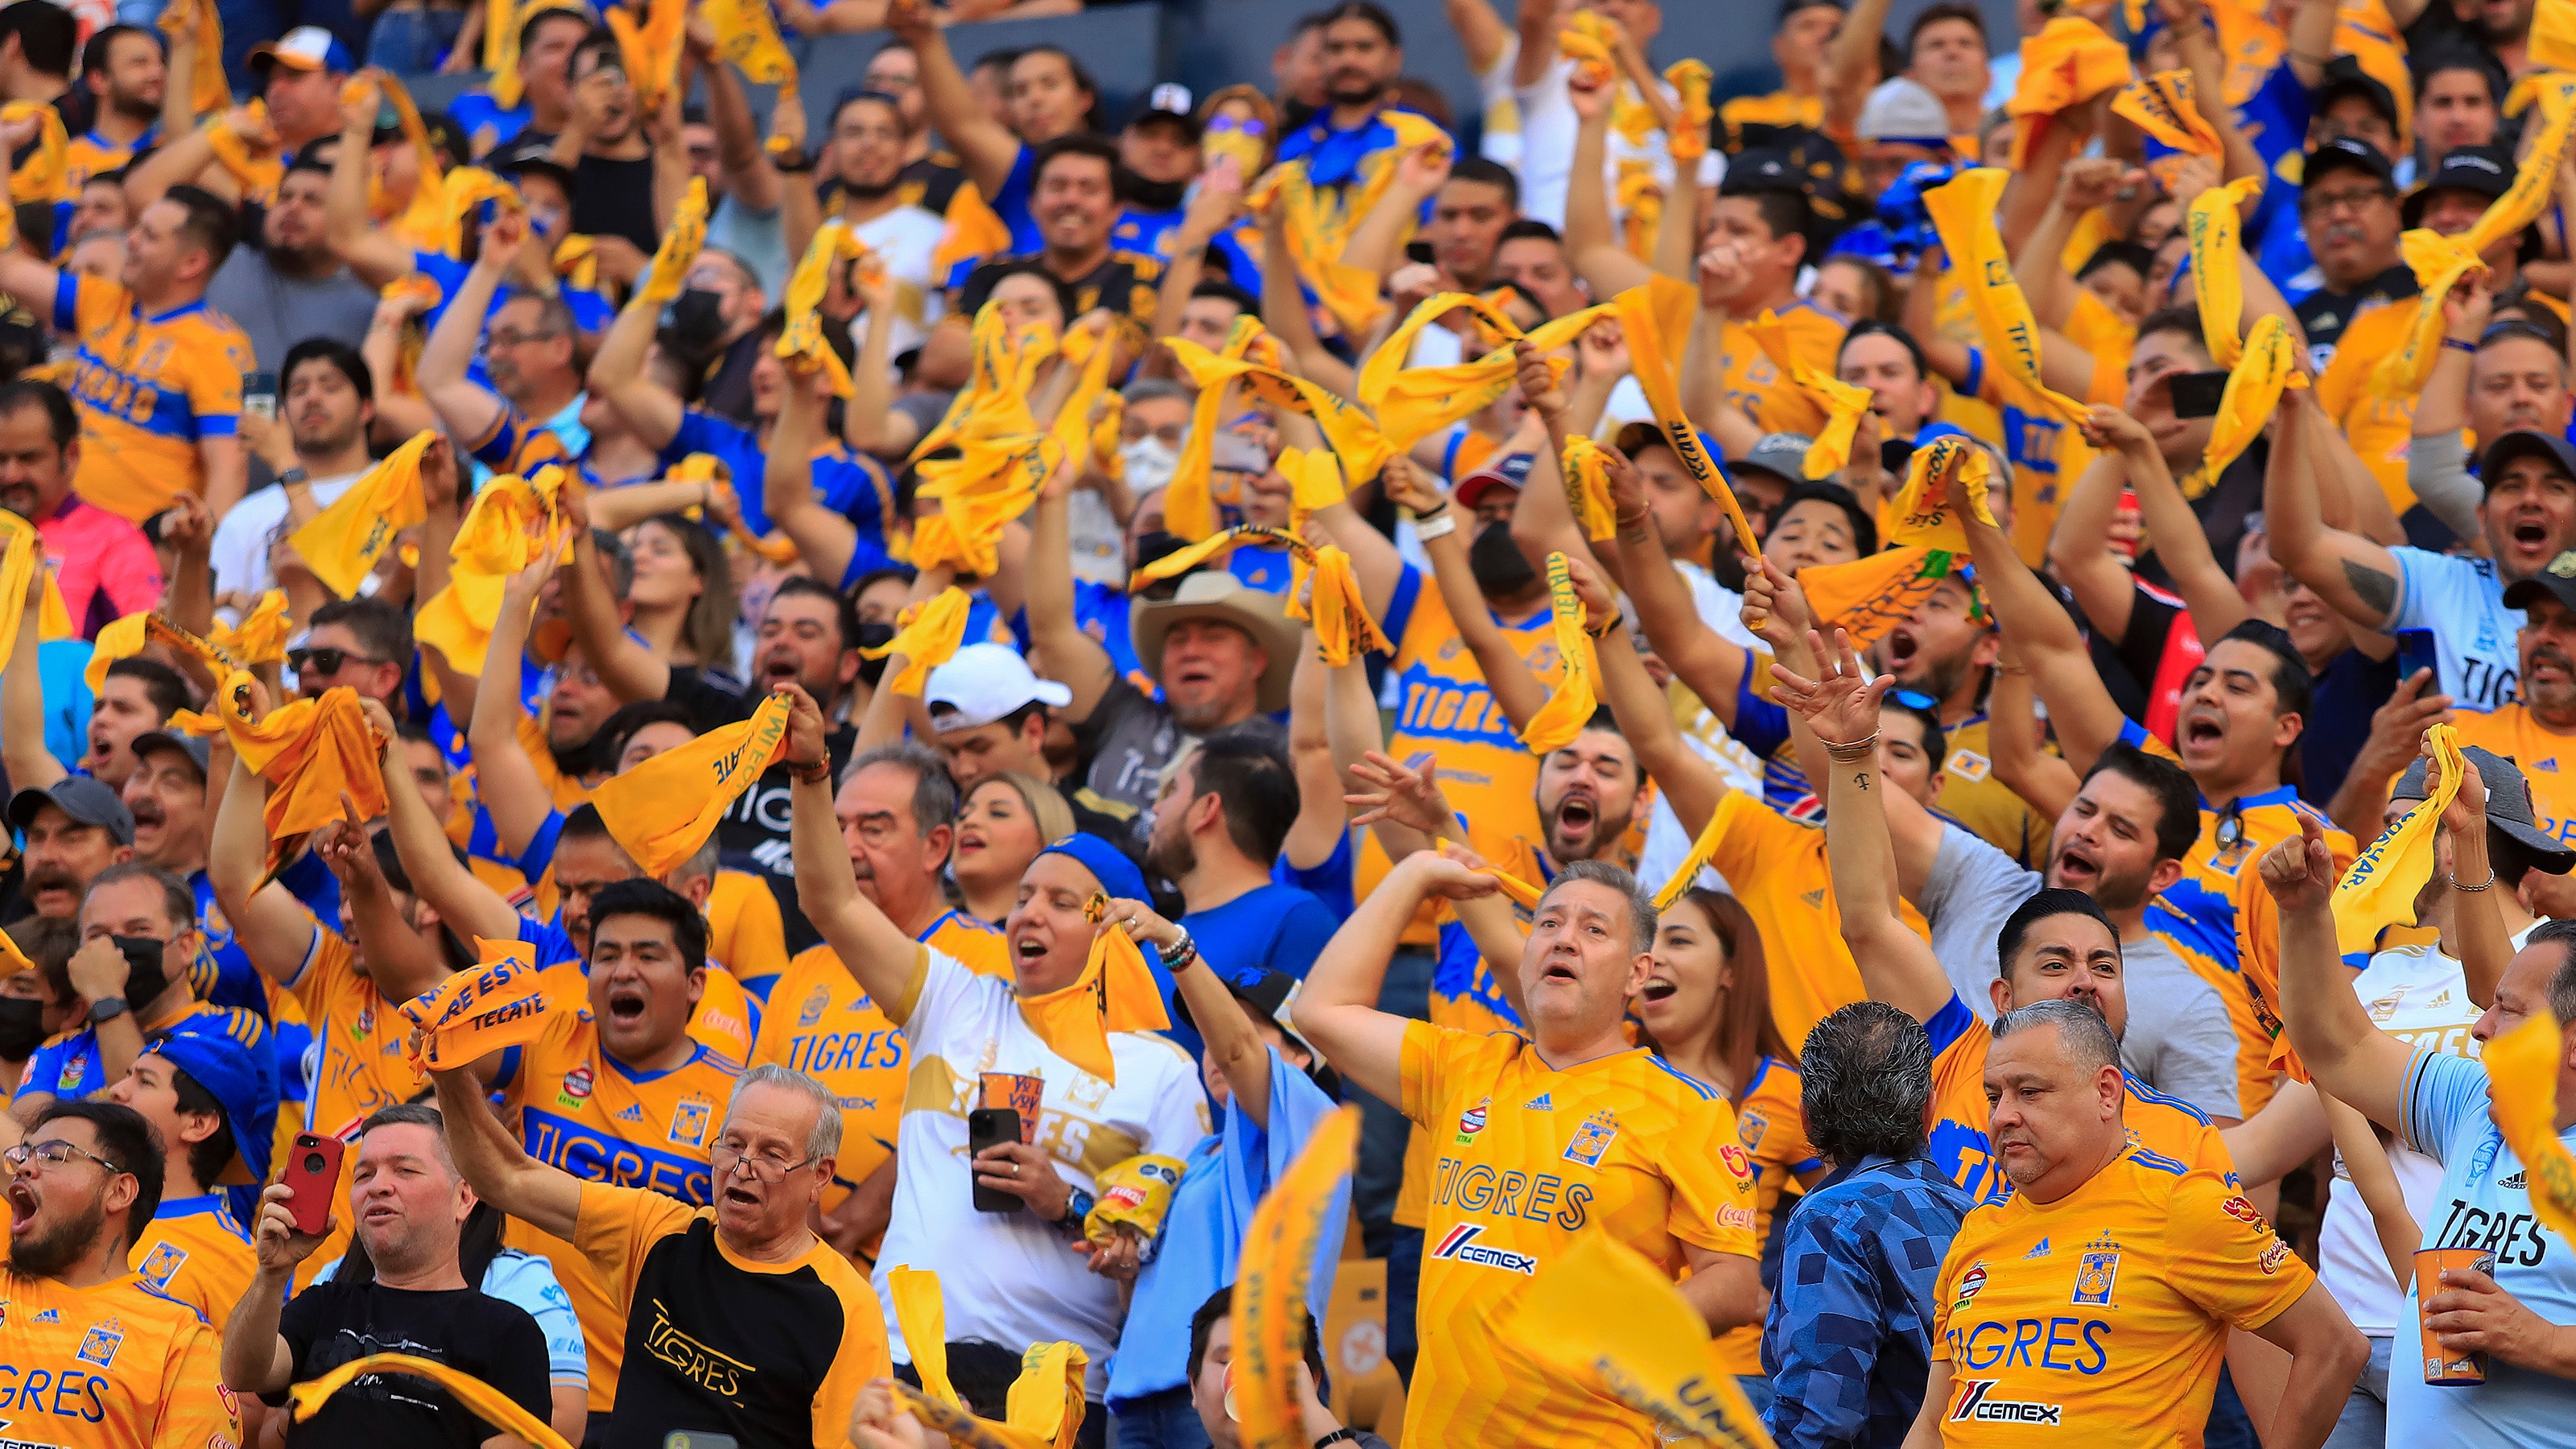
[208,338,376,613]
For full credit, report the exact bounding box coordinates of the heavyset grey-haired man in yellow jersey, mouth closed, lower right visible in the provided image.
[1906,993,2370,1449]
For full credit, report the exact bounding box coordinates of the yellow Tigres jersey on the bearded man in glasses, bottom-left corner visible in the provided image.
[0,1269,242,1449]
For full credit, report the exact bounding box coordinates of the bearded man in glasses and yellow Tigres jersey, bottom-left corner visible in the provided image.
[0,1101,242,1449]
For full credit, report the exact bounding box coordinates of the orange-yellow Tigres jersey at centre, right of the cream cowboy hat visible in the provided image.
[1352,564,1567,946]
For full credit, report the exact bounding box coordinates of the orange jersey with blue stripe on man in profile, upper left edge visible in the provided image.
[54,274,253,523]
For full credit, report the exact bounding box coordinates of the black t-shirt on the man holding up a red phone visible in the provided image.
[268,1279,554,1449]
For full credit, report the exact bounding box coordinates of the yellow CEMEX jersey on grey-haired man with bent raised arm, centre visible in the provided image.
[1404,1021,1757,1449]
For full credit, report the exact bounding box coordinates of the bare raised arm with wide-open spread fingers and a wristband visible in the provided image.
[1773,629,1958,1021]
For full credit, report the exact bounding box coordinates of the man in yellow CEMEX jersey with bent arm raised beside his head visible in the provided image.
[1293,851,1762,1447]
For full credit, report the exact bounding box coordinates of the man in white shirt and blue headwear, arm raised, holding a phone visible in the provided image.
[786,691,1208,1413]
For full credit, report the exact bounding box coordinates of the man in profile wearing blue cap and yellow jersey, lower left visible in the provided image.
[108,1026,261,1323]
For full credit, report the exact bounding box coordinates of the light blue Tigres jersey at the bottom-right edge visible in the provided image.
[2388,1050,2576,1447]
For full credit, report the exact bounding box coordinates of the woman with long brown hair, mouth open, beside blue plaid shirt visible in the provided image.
[1628,887,1824,1413]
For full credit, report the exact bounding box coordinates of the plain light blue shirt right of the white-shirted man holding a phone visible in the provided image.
[1105,1046,1350,1408]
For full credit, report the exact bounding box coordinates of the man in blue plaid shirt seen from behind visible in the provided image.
[1762,1001,1971,1449]
